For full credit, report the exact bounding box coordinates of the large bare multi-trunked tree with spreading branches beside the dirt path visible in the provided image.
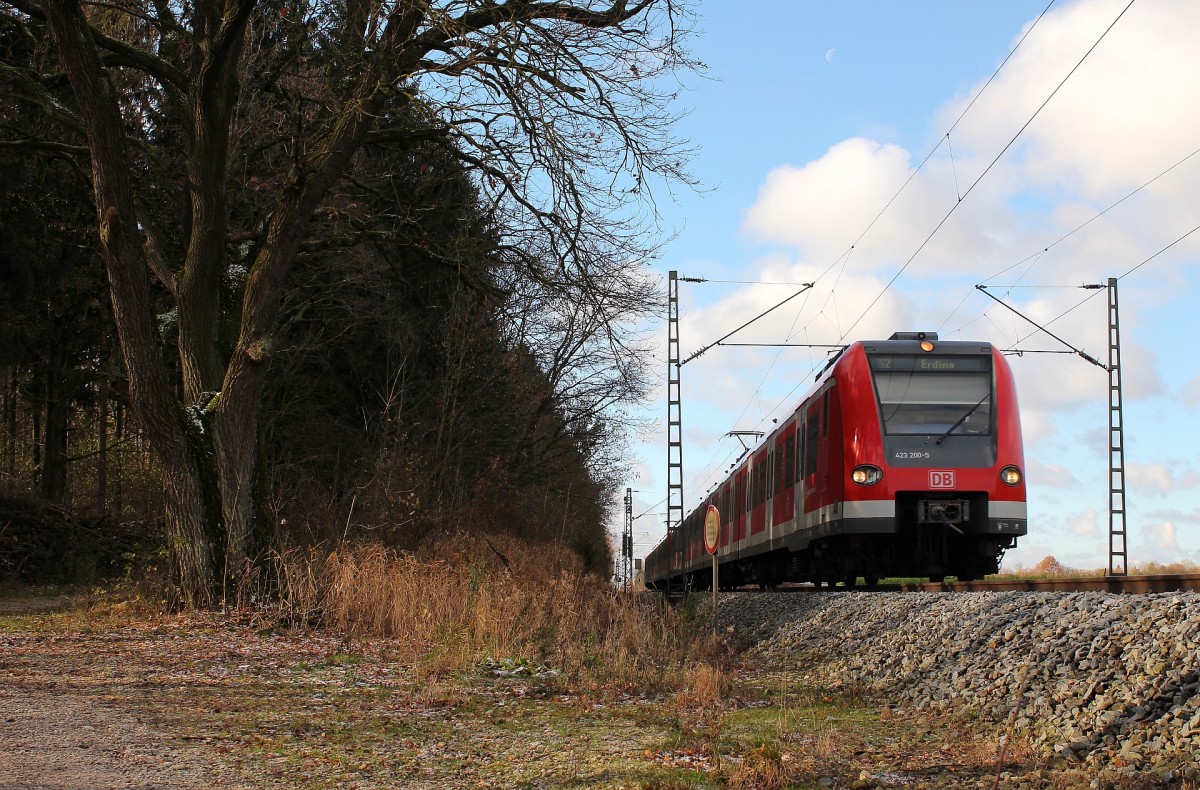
[0,0,691,605]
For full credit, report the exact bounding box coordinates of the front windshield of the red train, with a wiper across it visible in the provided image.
[869,354,995,436]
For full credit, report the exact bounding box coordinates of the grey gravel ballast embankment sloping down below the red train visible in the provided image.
[720,592,1200,780]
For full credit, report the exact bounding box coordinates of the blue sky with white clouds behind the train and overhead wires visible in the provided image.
[630,0,1200,568]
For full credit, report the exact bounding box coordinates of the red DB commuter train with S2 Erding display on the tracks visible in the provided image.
[646,333,1027,589]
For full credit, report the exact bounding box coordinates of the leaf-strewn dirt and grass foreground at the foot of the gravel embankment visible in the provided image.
[0,591,1171,790]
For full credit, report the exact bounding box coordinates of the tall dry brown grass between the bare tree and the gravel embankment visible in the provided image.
[265,535,719,695]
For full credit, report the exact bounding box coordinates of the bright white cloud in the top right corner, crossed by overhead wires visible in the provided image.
[942,0,1200,198]
